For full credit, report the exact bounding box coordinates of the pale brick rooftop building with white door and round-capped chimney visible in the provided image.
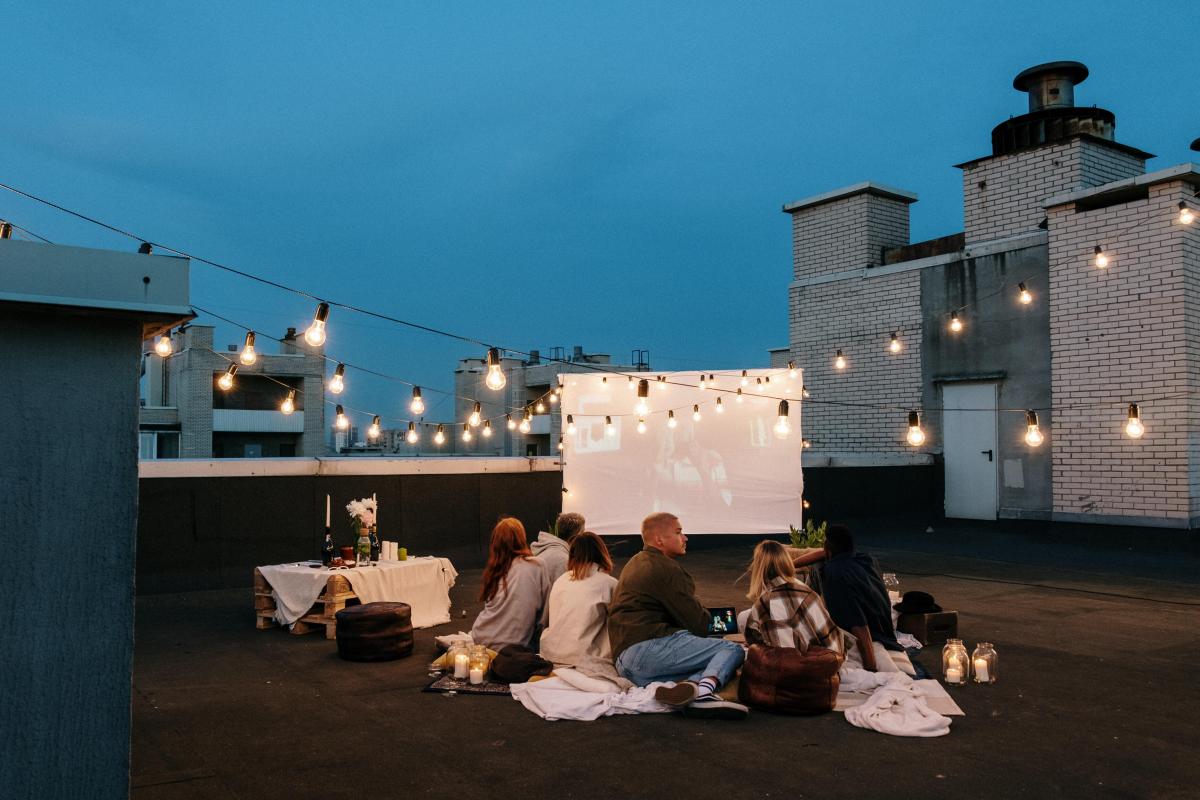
[772,61,1200,528]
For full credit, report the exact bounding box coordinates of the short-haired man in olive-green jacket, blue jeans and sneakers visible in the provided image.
[608,512,749,718]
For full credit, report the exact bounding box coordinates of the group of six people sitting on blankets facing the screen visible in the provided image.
[472,512,902,718]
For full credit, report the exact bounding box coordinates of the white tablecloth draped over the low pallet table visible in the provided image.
[258,555,458,627]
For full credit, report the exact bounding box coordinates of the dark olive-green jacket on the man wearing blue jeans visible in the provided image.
[608,546,708,661]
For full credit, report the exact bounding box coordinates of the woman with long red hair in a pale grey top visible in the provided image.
[470,517,550,650]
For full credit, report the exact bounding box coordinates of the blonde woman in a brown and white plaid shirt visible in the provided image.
[745,540,845,656]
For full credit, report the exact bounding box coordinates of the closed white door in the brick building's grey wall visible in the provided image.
[942,384,1000,519]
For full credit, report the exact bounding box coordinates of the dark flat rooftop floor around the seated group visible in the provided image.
[132,527,1200,800]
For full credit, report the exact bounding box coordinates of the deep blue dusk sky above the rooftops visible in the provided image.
[0,1,1200,425]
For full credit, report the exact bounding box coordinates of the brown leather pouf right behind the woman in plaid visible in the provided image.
[738,644,841,714]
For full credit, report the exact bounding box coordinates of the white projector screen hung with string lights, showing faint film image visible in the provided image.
[559,369,804,535]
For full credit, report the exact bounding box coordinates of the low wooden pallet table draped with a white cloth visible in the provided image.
[254,555,458,639]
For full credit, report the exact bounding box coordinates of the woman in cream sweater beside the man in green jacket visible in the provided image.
[541,531,617,674]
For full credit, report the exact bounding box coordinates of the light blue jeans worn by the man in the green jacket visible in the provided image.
[617,631,745,686]
